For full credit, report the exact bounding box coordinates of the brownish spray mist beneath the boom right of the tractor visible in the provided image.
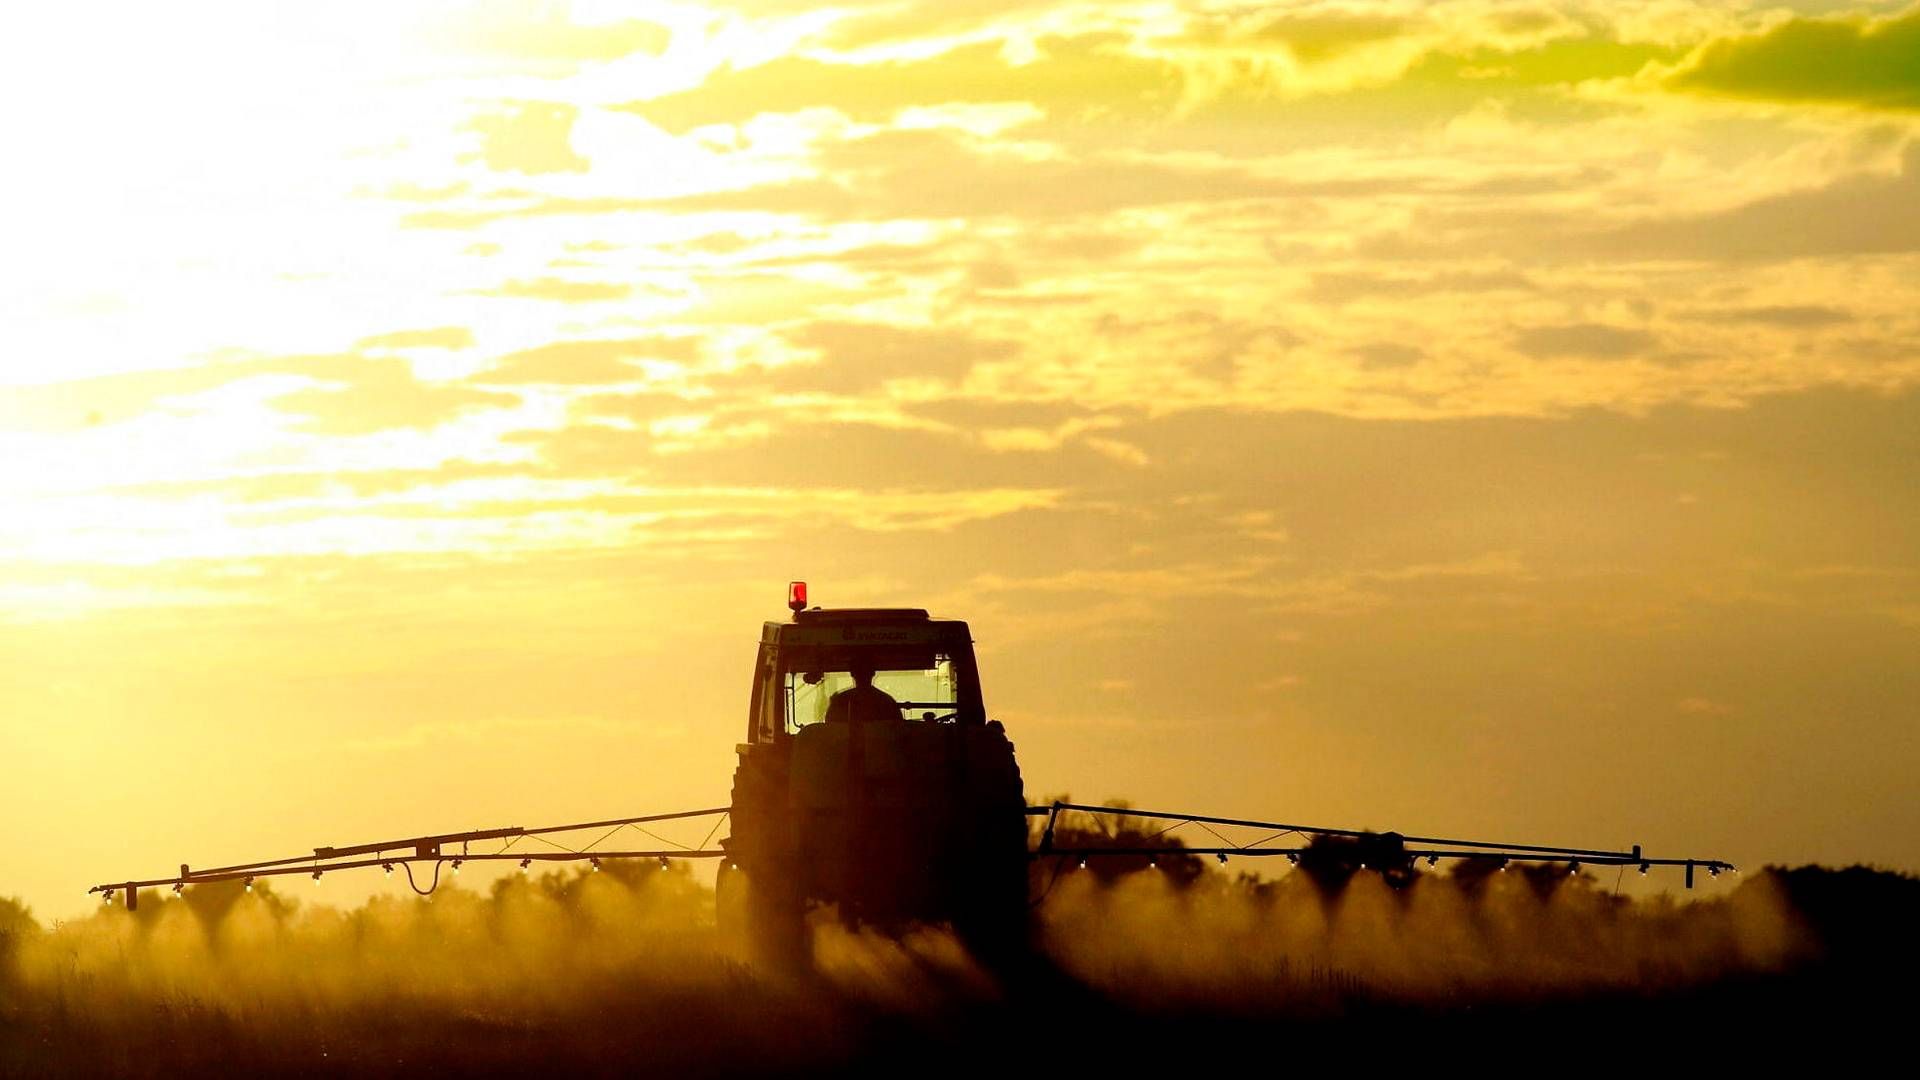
[1041,853,1816,1011]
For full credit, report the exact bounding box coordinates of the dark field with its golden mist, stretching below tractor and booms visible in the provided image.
[0,849,1920,1076]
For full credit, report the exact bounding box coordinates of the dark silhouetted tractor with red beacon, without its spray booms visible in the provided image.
[716,582,1027,957]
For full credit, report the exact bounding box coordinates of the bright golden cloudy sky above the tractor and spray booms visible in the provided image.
[0,0,1920,917]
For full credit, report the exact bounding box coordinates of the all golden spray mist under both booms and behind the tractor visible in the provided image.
[10,863,1812,1019]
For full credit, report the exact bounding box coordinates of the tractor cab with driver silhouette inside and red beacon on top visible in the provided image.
[747,582,987,746]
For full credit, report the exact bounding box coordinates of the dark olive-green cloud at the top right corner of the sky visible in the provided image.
[1665,8,1920,110]
